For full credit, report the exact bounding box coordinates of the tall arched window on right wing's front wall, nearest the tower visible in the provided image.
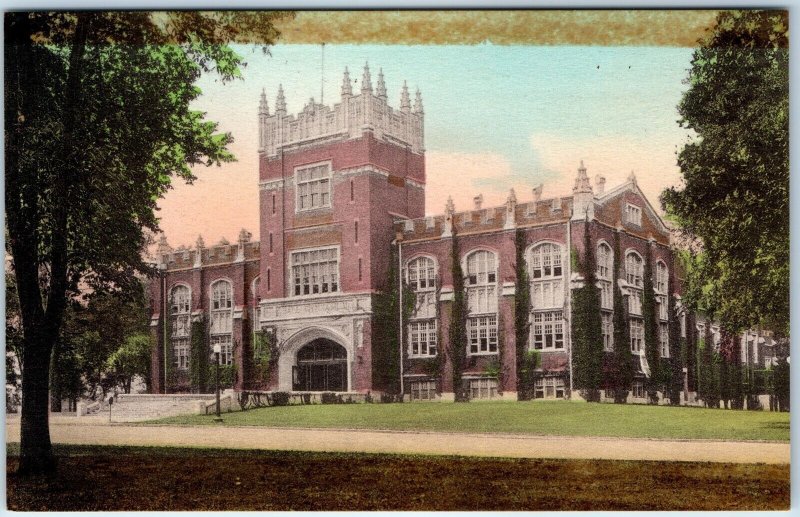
[405,257,437,357]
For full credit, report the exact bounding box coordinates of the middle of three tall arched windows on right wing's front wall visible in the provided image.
[465,250,497,355]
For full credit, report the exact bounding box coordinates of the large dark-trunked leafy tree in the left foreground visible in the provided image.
[4,11,290,473]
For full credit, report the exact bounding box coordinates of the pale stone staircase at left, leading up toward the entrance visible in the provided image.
[108,394,222,422]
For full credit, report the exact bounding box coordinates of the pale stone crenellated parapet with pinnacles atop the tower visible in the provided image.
[258,65,425,157]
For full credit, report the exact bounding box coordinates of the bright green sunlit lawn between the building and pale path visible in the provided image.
[148,401,789,441]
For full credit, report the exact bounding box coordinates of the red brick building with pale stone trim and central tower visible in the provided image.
[150,63,768,400]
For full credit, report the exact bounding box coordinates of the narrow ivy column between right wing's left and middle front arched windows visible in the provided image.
[448,228,469,402]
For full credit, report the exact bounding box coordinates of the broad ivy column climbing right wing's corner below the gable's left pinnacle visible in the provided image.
[572,222,603,402]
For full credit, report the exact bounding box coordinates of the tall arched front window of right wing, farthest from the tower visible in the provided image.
[530,242,564,350]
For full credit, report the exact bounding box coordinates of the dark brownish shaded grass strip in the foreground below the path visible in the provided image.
[6,444,790,511]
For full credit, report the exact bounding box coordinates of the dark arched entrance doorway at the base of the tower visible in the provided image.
[292,338,347,391]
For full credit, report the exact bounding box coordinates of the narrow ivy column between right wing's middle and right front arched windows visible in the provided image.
[514,228,536,400]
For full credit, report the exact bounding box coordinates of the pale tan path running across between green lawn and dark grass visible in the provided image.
[6,418,789,464]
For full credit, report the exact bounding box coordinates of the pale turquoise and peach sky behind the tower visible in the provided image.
[159,42,692,246]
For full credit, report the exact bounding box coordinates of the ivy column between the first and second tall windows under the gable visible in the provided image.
[608,232,633,404]
